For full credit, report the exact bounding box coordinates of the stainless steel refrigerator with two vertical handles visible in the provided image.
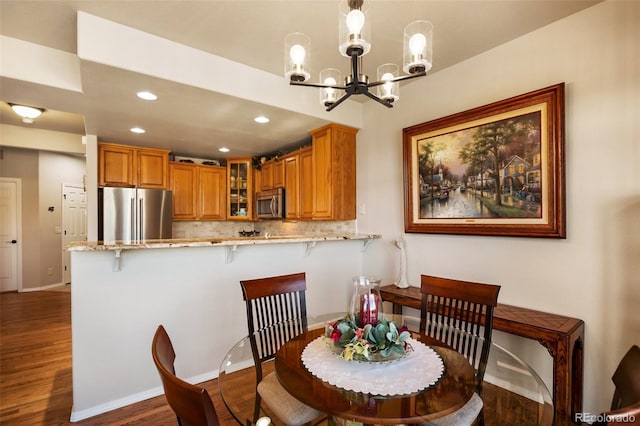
[98,187,172,243]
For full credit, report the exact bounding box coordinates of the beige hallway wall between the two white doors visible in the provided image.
[0,143,85,290]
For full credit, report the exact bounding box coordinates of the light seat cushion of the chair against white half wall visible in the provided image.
[258,373,322,426]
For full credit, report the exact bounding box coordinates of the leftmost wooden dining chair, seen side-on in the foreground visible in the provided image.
[151,325,220,426]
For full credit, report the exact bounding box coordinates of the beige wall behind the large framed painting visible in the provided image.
[358,1,640,413]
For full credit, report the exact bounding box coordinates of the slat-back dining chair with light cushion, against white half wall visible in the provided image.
[240,273,322,425]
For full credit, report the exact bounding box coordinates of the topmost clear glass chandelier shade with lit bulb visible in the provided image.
[338,0,371,57]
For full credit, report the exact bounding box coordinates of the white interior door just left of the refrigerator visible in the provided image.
[62,183,87,284]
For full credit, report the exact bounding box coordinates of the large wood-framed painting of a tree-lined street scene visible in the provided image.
[403,83,566,238]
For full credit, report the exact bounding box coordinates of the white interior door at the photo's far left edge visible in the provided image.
[0,178,22,291]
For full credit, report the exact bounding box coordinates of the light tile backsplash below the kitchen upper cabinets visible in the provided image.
[173,220,357,238]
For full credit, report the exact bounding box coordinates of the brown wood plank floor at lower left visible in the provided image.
[0,291,238,426]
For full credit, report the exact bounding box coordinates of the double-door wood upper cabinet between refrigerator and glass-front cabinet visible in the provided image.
[169,163,227,220]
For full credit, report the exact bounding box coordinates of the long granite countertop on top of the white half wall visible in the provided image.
[66,234,382,251]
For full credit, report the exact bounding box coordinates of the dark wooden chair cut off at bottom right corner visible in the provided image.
[593,345,640,425]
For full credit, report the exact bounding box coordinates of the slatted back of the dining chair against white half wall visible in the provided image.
[240,273,307,362]
